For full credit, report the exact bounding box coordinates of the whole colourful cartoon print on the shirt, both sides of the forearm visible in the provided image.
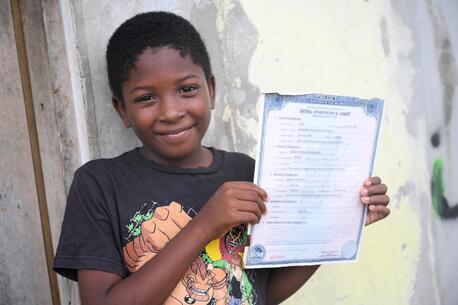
[123,202,256,305]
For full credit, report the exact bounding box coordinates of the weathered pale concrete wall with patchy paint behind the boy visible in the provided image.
[14,0,458,305]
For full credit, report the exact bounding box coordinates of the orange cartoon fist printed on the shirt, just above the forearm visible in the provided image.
[123,202,191,272]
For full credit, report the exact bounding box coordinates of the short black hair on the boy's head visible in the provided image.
[106,12,212,101]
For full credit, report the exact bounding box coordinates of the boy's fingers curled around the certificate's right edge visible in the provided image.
[360,177,390,226]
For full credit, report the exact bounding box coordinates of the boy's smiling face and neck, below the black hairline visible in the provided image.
[113,47,215,167]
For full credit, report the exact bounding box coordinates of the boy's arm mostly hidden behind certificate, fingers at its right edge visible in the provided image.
[266,177,390,304]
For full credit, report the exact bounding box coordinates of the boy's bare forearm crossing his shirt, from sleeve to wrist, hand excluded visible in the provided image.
[78,217,208,305]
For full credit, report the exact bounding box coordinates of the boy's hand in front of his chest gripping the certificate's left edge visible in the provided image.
[195,181,268,240]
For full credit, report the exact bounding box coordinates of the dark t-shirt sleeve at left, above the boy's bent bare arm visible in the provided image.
[53,168,126,281]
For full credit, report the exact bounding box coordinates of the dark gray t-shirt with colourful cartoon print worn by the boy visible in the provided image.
[54,149,269,304]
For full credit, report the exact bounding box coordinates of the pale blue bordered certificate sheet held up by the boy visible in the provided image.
[244,94,383,268]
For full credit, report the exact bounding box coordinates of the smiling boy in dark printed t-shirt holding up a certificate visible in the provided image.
[54,12,389,305]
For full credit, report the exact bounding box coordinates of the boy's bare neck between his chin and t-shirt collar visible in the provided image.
[139,146,213,168]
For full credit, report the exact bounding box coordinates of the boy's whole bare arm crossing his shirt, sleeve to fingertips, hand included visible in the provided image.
[78,182,267,305]
